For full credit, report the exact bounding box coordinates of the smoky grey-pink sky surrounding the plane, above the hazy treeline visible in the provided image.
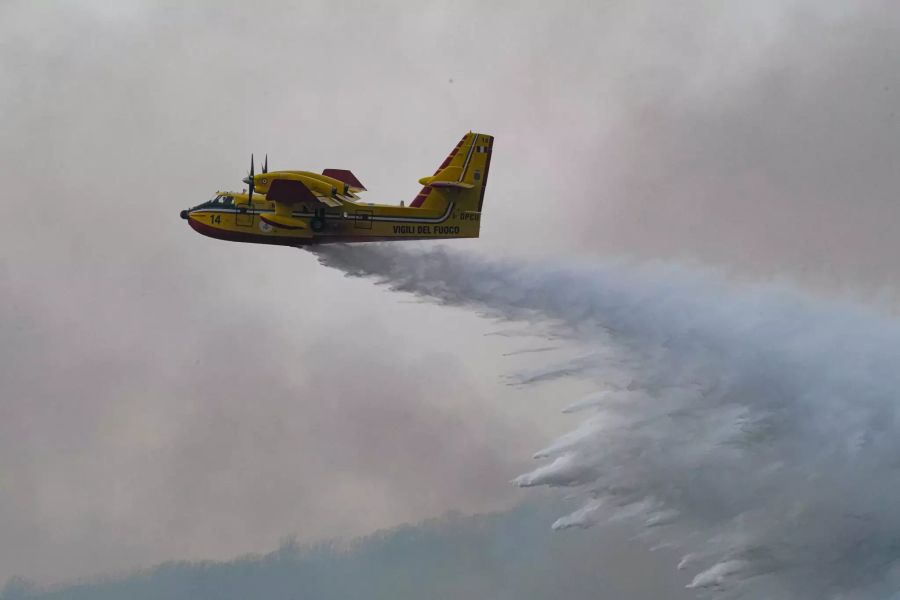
[0,0,900,592]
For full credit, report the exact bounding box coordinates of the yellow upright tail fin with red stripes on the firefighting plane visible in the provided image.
[410,131,494,212]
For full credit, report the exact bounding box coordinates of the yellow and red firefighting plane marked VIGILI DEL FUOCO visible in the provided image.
[181,132,494,246]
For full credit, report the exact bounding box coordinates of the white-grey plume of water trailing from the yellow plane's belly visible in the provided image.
[317,246,900,599]
